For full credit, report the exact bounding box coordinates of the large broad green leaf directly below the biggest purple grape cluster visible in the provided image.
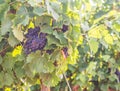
[27,51,54,73]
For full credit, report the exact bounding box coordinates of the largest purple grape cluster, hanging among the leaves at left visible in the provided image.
[23,27,47,54]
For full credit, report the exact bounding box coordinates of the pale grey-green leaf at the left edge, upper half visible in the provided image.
[1,18,12,35]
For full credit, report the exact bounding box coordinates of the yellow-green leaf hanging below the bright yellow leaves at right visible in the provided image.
[89,39,99,53]
